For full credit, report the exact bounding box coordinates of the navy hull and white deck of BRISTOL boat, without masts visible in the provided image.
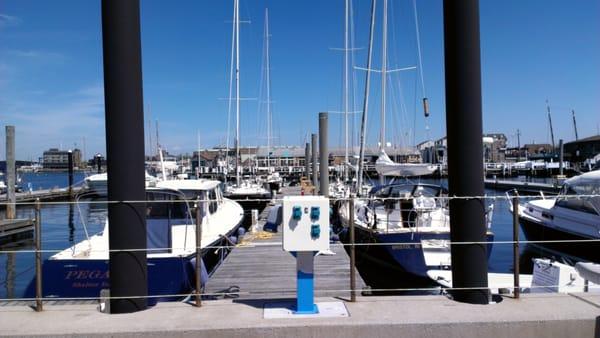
[339,183,494,279]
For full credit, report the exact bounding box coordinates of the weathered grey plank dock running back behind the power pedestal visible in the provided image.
[205,187,365,299]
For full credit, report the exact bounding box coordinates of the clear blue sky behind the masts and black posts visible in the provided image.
[0,0,600,159]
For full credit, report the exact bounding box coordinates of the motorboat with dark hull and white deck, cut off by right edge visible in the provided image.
[519,170,600,262]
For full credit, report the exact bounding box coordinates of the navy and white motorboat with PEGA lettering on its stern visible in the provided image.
[25,180,243,301]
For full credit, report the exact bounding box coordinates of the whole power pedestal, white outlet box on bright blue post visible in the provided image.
[282,196,329,314]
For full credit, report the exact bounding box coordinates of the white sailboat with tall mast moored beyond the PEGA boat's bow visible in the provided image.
[224,0,271,211]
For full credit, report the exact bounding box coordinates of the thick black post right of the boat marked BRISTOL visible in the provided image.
[444,0,489,304]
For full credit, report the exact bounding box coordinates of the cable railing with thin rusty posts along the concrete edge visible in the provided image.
[0,194,600,310]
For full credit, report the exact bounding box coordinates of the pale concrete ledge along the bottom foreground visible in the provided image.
[0,294,600,338]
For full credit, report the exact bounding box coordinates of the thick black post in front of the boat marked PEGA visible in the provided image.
[102,0,148,313]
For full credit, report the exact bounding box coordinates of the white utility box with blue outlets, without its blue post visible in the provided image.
[282,196,329,251]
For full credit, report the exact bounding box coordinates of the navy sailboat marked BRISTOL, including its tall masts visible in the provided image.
[339,0,494,285]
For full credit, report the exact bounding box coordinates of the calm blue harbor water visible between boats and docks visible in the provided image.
[0,173,556,299]
